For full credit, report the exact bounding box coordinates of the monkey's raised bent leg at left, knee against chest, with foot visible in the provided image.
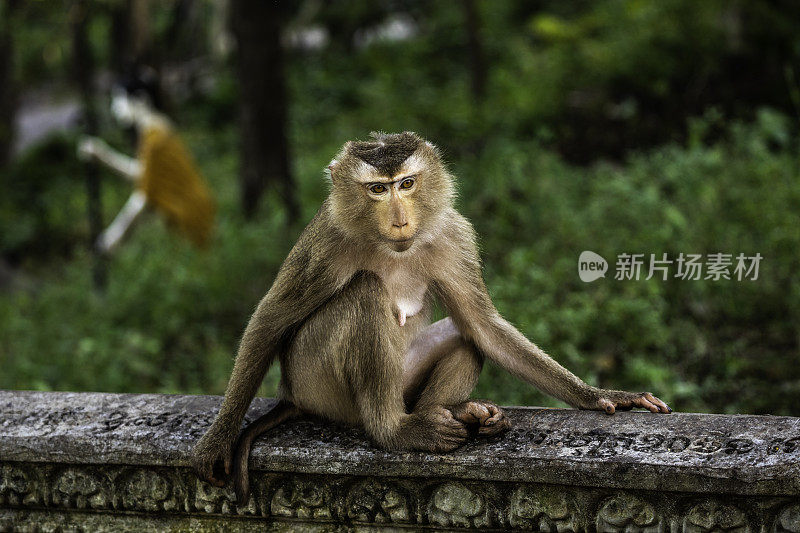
[285,272,468,452]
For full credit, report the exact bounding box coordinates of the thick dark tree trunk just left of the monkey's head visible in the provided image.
[230,0,298,220]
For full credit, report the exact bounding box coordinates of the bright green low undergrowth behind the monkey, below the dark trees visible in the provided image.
[0,110,800,413]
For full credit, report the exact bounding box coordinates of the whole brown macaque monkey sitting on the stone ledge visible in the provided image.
[193,132,671,502]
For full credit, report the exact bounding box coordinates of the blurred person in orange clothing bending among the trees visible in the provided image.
[78,71,216,254]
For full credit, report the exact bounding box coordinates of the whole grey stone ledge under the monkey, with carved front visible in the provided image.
[0,391,800,533]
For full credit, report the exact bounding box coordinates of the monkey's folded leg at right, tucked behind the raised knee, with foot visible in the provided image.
[403,318,511,435]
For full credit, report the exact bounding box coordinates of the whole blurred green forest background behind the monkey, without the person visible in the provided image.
[0,0,800,416]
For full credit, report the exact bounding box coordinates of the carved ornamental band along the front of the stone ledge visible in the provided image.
[0,463,800,533]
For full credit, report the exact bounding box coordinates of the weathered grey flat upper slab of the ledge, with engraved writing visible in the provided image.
[0,391,800,495]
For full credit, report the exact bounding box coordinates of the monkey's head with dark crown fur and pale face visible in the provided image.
[328,131,455,252]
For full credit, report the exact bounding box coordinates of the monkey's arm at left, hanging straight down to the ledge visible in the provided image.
[194,206,346,485]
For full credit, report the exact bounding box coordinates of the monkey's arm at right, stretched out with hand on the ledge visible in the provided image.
[434,219,670,413]
